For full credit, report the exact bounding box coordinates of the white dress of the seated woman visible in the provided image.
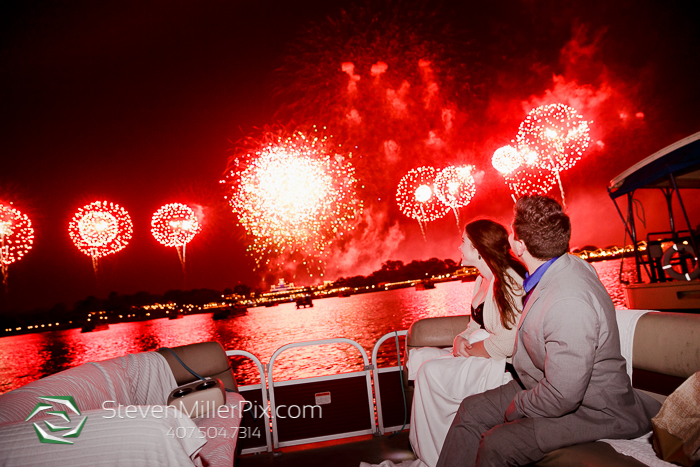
[408,274,516,467]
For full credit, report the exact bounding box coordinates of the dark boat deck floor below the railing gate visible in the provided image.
[236,430,415,467]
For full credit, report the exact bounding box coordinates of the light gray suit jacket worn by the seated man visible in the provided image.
[506,254,661,452]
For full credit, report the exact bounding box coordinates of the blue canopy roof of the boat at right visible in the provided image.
[608,132,700,199]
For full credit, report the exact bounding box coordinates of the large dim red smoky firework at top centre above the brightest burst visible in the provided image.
[277,3,471,205]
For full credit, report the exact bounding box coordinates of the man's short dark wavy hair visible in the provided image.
[513,195,571,261]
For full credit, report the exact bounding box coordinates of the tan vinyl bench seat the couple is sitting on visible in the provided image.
[404,312,700,467]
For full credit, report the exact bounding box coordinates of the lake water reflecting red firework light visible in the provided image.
[0,259,634,393]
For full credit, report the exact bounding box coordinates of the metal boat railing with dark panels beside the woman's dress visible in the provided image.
[226,330,410,454]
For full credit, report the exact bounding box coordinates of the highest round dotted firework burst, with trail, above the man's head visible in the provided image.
[517,104,591,205]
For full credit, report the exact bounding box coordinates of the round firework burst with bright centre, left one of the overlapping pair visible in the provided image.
[396,166,449,238]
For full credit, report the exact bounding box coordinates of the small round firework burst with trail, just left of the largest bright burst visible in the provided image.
[151,203,201,274]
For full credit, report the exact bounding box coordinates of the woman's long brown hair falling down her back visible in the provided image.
[465,219,526,329]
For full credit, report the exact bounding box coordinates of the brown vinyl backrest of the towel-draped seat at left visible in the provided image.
[157,342,238,392]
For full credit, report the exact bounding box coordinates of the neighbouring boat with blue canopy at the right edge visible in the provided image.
[608,132,700,313]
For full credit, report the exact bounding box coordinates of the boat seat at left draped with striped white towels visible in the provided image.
[0,342,244,467]
